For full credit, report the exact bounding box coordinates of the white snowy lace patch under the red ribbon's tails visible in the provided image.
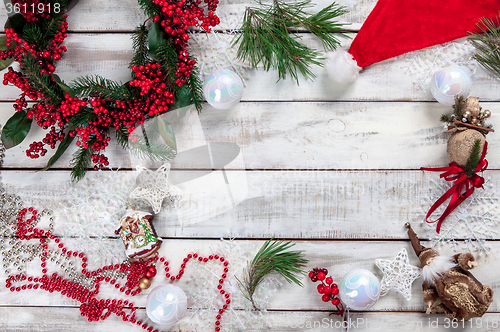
[422,179,500,256]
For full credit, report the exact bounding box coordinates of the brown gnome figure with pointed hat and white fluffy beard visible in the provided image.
[405,223,493,321]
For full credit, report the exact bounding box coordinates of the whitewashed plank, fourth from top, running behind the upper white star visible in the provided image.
[1,171,500,240]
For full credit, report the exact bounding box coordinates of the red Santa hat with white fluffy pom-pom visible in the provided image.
[325,0,500,83]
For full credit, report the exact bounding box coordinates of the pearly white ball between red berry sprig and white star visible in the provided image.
[339,269,380,310]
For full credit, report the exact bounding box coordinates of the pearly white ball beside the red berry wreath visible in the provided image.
[203,69,243,109]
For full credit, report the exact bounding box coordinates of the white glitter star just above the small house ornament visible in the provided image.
[130,163,181,213]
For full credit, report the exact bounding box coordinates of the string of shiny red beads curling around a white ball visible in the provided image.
[5,208,231,332]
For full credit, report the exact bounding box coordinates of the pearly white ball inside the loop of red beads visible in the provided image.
[146,285,187,326]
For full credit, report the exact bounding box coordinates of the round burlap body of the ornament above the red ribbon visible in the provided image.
[446,129,486,168]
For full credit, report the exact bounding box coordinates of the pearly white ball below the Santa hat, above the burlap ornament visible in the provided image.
[430,66,472,106]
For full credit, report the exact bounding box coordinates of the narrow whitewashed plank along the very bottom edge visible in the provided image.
[0,307,500,332]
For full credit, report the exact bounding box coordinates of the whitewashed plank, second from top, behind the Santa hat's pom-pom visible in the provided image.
[0,33,500,101]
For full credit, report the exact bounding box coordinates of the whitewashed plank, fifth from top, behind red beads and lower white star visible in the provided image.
[0,239,500,312]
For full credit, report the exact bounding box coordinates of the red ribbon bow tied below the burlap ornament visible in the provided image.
[420,142,488,233]
